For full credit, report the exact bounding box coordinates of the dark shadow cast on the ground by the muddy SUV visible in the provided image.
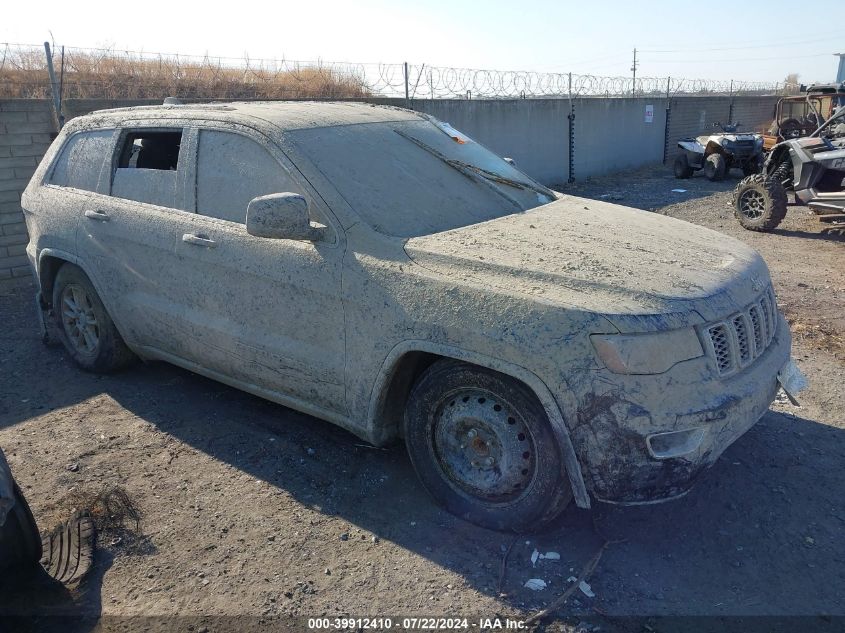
[0,284,845,617]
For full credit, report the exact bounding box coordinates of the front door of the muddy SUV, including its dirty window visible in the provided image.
[175,128,346,414]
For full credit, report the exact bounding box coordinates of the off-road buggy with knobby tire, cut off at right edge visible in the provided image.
[733,106,845,231]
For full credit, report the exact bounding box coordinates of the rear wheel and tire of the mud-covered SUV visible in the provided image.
[53,264,135,374]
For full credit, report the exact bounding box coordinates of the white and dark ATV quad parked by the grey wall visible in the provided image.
[674,123,763,180]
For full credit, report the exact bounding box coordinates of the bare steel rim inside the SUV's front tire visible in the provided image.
[432,389,536,503]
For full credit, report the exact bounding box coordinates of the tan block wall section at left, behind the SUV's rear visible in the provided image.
[0,99,55,285]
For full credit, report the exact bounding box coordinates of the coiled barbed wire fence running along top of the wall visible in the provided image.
[0,43,798,100]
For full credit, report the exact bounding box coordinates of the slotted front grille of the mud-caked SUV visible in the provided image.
[706,287,777,376]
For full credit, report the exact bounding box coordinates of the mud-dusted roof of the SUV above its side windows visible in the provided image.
[73,101,420,131]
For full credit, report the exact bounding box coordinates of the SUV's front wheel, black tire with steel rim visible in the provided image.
[404,360,572,532]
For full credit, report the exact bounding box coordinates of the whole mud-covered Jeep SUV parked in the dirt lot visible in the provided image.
[22,103,804,530]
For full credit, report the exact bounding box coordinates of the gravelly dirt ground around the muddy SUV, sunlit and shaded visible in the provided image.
[0,167,845,632]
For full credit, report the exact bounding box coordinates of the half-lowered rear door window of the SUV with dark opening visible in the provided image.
[111,130,182,208]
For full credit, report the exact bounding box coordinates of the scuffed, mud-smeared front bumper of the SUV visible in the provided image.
[571,315,791,504]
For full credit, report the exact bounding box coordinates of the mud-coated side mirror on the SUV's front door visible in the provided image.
[246,193,322,241]
